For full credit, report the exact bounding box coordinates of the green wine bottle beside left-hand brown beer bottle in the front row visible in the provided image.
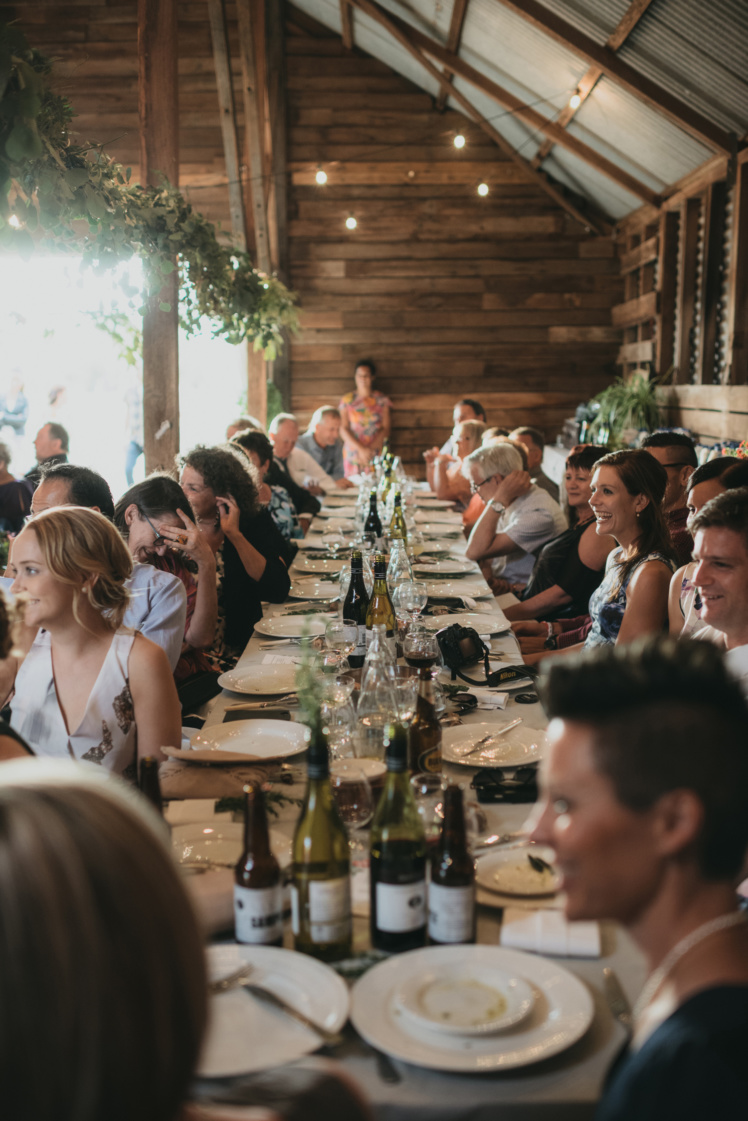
[290,720,352,962]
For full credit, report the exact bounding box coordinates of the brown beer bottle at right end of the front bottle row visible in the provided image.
[428,785,475,945]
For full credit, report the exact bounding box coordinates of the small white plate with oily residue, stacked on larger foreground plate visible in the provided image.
[395,962,535,1036]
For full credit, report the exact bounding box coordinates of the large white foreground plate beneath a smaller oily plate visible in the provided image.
[351,946,594,1074]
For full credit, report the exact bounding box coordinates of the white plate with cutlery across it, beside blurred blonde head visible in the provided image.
[197,945,350,1078]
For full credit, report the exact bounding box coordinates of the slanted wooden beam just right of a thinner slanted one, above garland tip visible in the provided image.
[237,0,271,272]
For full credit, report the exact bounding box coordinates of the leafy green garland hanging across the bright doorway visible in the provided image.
[0,25,298,359]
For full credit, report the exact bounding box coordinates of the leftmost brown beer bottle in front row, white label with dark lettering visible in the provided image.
[233,782,283,946]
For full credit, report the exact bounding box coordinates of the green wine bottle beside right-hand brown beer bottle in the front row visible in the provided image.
[370,724,426,953]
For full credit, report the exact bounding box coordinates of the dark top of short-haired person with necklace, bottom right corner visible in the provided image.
[594,985,748,1121]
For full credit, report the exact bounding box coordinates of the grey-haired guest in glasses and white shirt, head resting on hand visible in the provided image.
[462,443,566,585]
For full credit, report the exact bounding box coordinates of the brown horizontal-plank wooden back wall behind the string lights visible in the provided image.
[286,10,622,475]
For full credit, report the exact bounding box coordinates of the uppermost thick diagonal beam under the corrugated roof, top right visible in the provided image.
[496,0,736,154]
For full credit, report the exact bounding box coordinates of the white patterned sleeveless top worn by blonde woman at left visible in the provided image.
[10,628,138,781]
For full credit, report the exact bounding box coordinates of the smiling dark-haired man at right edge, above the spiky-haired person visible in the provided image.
[689,487,748,697]
